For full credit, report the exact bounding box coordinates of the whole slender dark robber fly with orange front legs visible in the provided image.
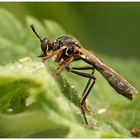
[30,24,137,125]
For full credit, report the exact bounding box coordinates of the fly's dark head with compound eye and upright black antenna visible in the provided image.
[30,24,52,57]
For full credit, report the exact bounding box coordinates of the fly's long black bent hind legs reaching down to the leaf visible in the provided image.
[66,67,96,125]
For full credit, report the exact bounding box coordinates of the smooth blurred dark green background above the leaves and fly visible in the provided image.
[0,2,140,59]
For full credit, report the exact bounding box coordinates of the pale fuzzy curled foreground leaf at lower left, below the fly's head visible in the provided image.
[0,62,97,137]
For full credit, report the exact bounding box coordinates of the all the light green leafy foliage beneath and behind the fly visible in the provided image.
[0,9,140,138]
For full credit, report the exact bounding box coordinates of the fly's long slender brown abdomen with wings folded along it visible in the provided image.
[81,48,137,100]
